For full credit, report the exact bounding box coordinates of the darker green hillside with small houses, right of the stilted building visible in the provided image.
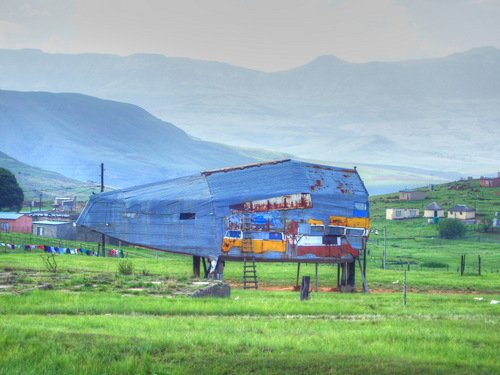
[367,180,500,278]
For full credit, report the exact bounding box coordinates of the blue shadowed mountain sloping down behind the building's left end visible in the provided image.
[0,90,287,187]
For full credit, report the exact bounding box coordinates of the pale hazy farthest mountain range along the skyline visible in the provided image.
[0,47,500,175]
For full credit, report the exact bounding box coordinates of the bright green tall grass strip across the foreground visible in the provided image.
[0,291,500,374]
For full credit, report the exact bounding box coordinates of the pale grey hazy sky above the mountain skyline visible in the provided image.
[0,0,500,71]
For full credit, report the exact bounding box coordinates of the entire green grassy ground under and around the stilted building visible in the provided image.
[0,181,500,374]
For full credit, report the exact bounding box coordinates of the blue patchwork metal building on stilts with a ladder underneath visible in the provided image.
[77,159,370,291]
